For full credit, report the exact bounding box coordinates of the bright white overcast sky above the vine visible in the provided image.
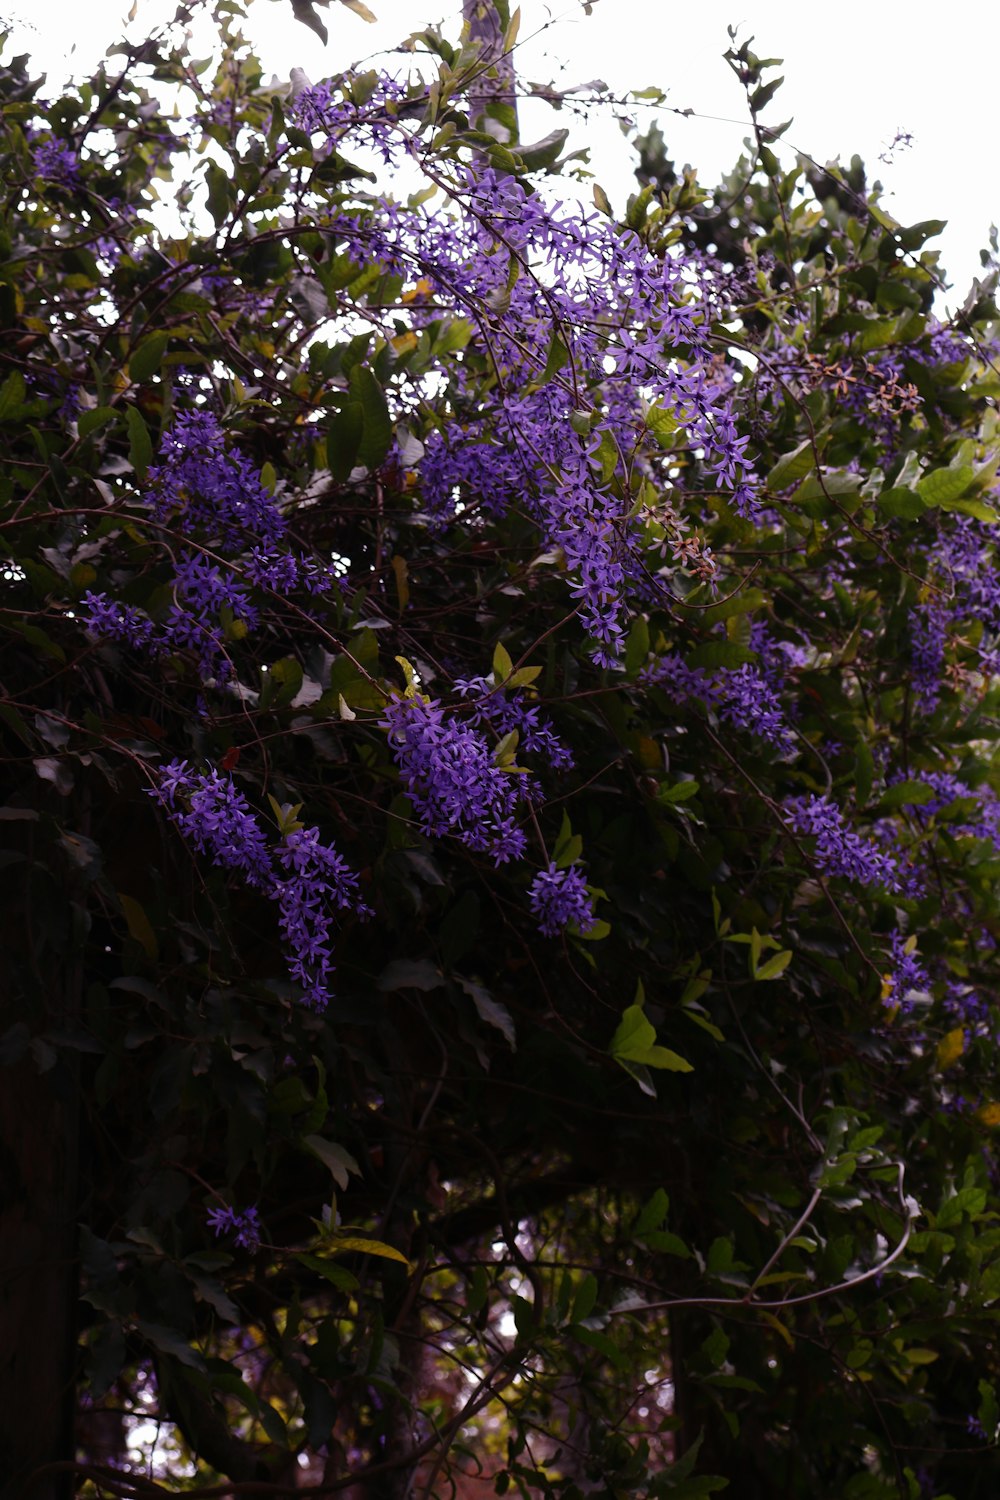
[7,0,1000,306]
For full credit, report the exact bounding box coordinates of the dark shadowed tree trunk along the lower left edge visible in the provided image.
[0,809,87,1500]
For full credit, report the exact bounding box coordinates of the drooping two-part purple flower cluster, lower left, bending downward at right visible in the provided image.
[150,761,372,1010]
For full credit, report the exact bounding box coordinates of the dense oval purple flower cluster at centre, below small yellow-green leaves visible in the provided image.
[381,695,531,864]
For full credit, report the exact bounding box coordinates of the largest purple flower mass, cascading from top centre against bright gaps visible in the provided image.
[324,153,757,665]
